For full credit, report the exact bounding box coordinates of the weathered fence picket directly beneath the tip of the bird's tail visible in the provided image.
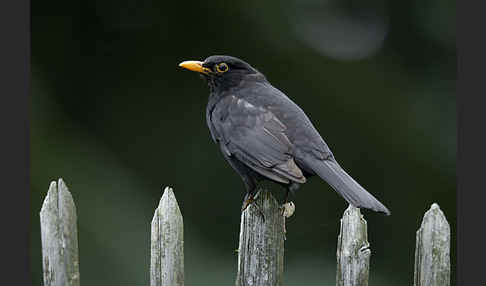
[336,205,371,286]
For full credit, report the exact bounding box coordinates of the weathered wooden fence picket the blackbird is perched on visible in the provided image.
[236,190,285,286]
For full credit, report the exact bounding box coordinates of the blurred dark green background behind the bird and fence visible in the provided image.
[31,0,456,286]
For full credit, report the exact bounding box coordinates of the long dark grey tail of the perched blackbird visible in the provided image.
[312,160,390,215]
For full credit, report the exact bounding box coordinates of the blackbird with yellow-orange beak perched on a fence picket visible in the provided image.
[179,55,390,215]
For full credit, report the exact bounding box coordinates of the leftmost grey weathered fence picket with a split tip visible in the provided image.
[40,179,79,286]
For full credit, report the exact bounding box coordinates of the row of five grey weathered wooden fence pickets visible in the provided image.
[40,179,450,286]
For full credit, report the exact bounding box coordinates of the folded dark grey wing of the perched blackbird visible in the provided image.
[211,96,305,183]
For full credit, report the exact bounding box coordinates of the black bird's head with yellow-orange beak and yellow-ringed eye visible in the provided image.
[179,56,265,90]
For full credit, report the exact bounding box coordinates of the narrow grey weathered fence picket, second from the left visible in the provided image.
[150,187,184,286]
